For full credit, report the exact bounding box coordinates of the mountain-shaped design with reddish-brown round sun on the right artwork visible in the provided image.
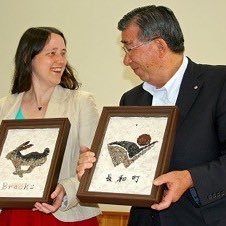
[107,134,158,168]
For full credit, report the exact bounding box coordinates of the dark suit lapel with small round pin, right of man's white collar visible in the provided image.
[176,59,203,127]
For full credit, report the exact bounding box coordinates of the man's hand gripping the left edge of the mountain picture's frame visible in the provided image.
[76,146,96,181]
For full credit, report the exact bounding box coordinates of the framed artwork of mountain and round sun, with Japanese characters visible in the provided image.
[77,106,178,207]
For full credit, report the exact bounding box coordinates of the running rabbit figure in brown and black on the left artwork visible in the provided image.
[6,141,50,177]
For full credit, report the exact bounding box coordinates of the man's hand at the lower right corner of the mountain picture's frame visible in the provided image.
[151,170,193,210]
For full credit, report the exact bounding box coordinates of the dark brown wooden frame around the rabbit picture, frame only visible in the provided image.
[0,118,70,208]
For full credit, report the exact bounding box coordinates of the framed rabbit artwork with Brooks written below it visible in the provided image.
[0,118,70,208]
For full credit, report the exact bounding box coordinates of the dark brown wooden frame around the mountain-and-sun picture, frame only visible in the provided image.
[77,106,178,207]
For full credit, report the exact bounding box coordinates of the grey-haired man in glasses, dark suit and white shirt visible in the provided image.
[77,5,226,226]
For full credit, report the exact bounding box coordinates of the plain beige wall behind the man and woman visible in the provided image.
[0,0,226,210]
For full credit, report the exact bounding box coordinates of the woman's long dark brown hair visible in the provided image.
[11,27,79,94]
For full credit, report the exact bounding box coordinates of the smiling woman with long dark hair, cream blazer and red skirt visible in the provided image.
[0,27,100,226]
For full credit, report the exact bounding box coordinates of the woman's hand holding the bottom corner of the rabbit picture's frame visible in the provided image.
[32,184,66,214]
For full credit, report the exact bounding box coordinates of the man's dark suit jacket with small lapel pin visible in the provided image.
[120,59,226,226]
